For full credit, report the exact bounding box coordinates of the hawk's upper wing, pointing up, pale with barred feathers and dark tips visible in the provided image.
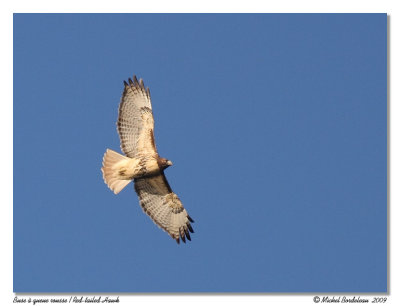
[117,76,157,157]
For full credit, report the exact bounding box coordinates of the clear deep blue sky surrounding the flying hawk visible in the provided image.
[13,14,387,292]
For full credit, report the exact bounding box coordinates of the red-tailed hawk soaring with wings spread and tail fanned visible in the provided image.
[101,76,194,243]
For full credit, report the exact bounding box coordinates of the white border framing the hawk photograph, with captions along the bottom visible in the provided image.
[0,0,400,306]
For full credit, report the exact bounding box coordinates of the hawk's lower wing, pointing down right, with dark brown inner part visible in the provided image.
[135,172,194,243]
